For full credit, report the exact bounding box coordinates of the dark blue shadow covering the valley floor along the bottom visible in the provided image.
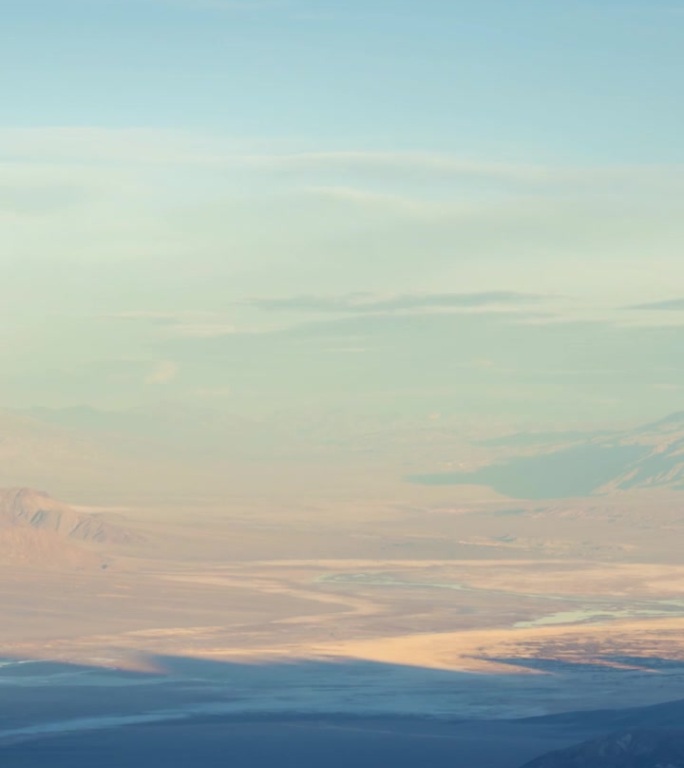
[0,655,684,768]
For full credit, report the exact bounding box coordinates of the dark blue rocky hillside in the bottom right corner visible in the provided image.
[522,729,684,768]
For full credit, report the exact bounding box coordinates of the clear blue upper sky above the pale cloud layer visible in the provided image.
[3,0,684,163]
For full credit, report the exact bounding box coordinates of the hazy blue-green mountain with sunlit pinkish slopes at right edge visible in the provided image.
[407,411,684,499]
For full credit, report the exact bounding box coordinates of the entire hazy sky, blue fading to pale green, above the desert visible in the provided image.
[0,0,684,425]
